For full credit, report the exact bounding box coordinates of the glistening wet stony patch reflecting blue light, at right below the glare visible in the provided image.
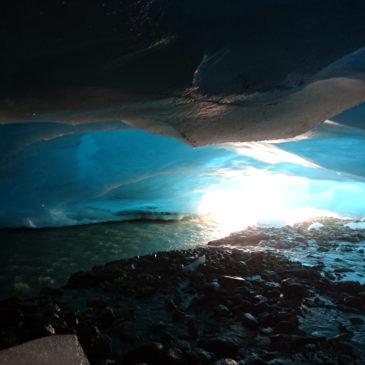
[209,218,365,284]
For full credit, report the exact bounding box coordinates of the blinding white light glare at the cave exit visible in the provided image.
[199,169,336,234]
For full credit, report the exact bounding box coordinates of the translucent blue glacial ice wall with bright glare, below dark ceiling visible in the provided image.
[0,107,365,227]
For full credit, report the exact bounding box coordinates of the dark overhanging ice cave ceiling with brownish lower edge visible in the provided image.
[0,0,365,145]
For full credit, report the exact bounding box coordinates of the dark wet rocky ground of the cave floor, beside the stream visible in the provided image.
[0,220,365,365]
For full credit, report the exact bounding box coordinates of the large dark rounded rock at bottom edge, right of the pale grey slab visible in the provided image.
[123,342,165,365]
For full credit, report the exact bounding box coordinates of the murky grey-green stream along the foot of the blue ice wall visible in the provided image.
[0,219,224,298]
